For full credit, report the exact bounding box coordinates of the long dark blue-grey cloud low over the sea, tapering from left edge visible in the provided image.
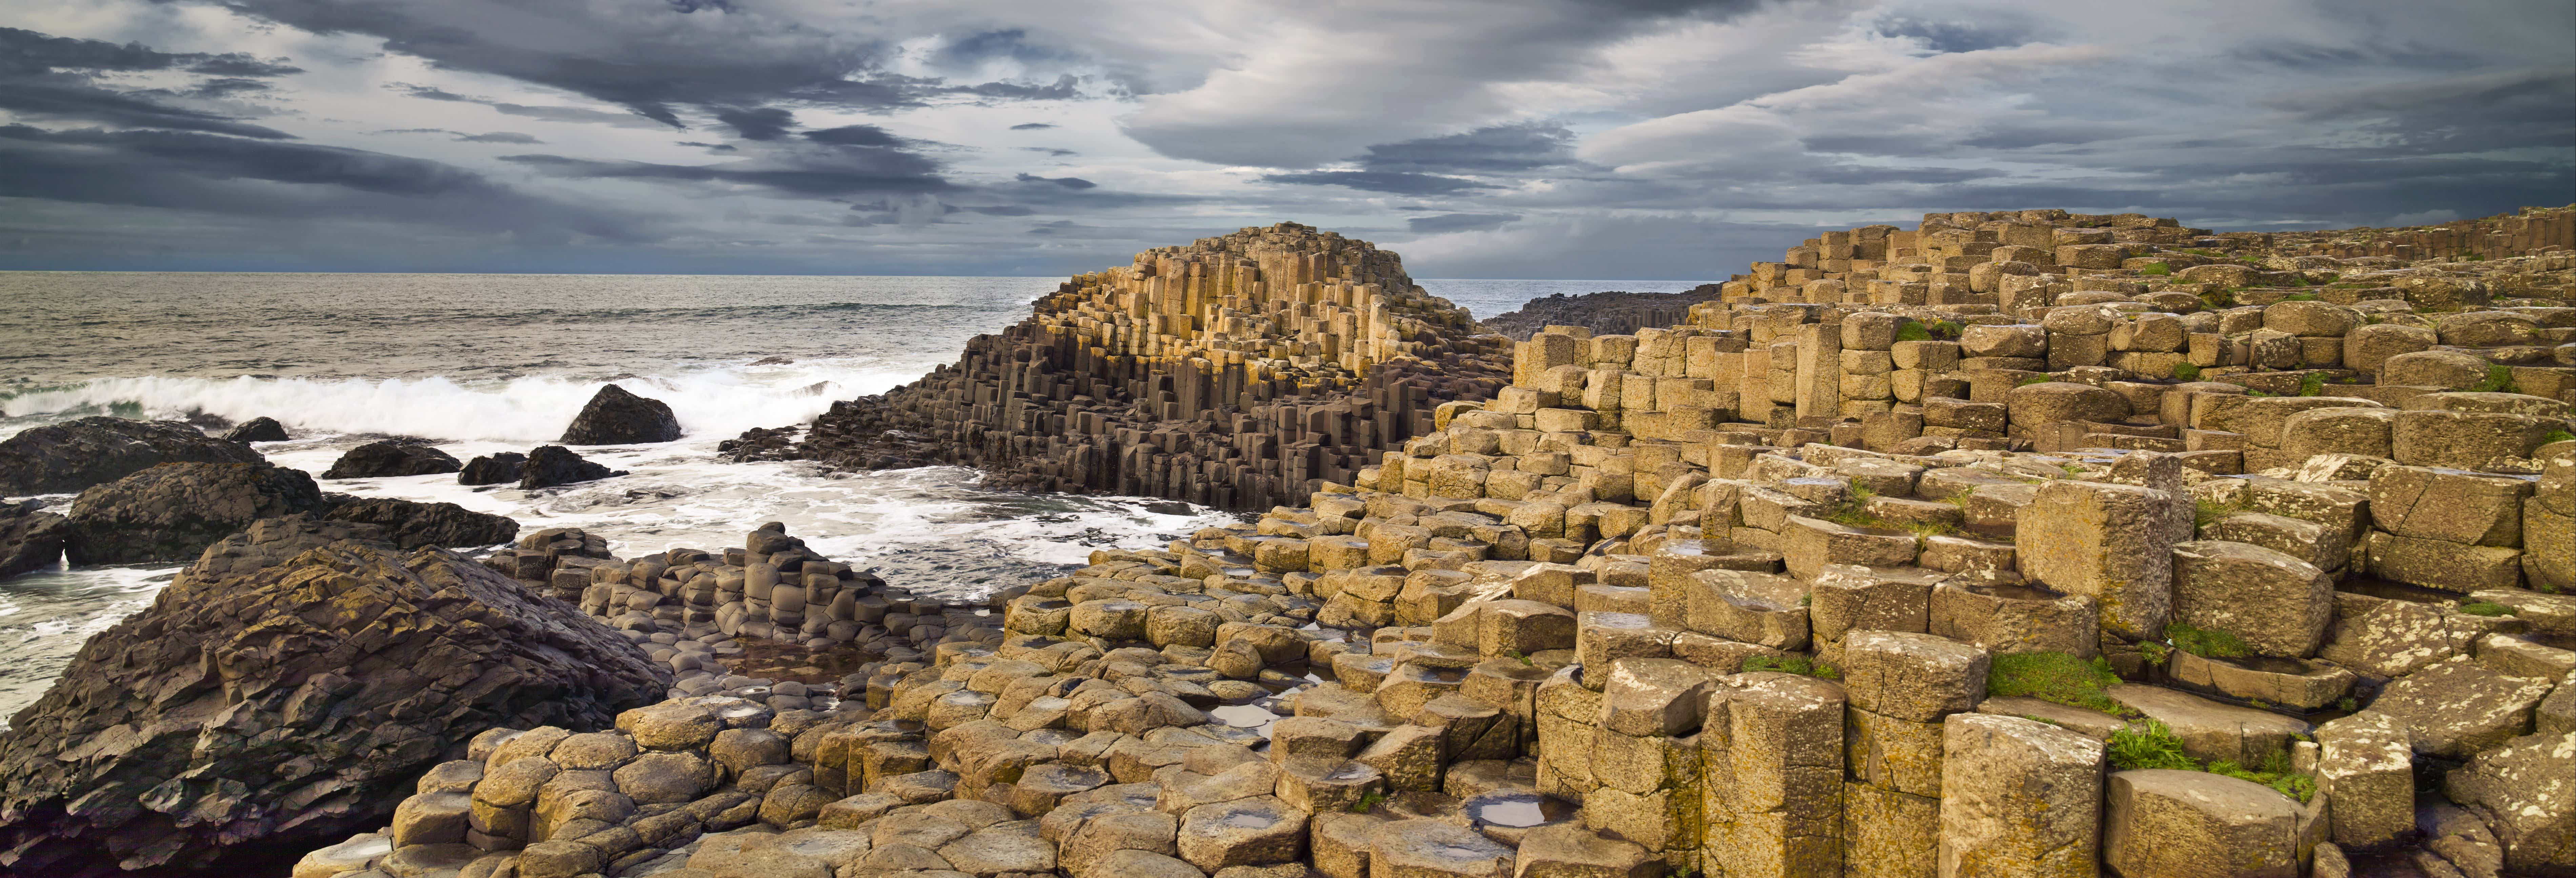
[0,124,657,242]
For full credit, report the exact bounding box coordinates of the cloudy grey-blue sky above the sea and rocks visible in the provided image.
[0,0,2576,278]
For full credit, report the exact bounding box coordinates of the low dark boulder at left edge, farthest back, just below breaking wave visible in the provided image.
[0,417,268,497]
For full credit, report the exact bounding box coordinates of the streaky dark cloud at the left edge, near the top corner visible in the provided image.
[0,28,301,139]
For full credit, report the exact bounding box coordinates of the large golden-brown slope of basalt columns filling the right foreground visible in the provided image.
[301,211,2576,878]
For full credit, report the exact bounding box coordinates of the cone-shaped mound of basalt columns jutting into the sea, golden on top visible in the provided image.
[732,224,1507,510]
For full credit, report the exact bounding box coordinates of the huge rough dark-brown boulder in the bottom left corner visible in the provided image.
[0,538,672,878]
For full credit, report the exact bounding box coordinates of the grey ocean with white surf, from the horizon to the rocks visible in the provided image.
[0,273,1692,716]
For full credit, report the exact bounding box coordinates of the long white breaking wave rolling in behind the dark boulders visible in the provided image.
[0,358,920,443]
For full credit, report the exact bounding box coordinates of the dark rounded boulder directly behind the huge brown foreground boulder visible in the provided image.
[67,464,322,564]
